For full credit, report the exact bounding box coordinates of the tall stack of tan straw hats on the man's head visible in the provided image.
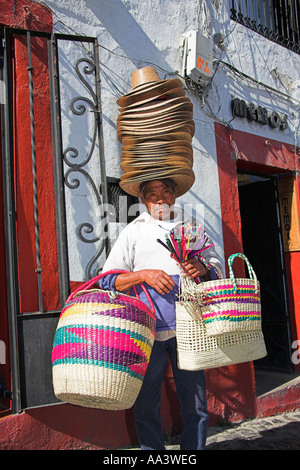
[117,67,195,197]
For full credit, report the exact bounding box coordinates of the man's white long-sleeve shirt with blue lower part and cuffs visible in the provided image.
[100,210,222,339]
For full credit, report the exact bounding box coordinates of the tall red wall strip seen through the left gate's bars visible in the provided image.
[14,32,59,313]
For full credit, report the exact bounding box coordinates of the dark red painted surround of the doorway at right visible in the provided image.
[215,123,300,369]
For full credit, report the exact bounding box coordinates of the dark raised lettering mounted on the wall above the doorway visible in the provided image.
[231,98,288,131]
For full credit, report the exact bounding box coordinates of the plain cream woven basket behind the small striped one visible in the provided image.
[176,301,267,370]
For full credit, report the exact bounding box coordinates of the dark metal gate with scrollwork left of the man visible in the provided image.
[0,29,109,413]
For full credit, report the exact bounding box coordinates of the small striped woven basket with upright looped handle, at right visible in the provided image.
[183,253,261,336]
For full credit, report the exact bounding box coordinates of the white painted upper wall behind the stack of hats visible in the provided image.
[41,0,300,280]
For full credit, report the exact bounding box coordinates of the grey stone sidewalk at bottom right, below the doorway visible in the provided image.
[166,409,300,450]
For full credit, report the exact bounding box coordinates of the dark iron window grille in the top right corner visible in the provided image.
[230,0,300,54]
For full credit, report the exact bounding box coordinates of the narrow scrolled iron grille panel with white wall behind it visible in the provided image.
[52,34,110,281]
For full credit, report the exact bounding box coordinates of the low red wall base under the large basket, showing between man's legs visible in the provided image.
[0,362,180,450]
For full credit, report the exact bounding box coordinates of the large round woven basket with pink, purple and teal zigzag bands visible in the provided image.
[52,271,156,410]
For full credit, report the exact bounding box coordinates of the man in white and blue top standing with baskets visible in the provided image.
[101,179,220,450]
